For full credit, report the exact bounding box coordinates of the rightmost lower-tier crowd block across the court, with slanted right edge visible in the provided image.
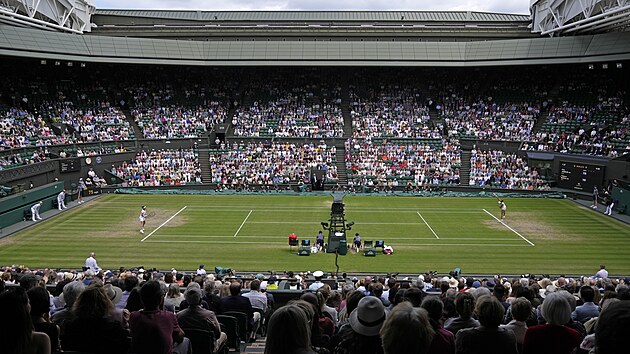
[469,147,549,190]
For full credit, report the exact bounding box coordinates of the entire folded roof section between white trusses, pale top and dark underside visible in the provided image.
[92,10,537,41]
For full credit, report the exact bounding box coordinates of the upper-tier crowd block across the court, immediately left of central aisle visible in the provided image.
[232,83,344,138]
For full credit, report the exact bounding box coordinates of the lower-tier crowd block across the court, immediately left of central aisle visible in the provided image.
[210,141,337,186]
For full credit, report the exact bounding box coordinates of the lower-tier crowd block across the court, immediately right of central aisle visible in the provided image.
[345,139,461,187]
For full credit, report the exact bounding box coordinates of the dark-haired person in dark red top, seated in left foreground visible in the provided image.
[129,280,190,354]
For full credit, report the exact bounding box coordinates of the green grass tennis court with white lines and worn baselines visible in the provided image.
[0,194,630,275]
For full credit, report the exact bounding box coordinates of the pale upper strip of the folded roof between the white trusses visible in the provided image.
[94,9,530,22]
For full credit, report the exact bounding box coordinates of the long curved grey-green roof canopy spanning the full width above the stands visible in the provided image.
[0,25,630,66]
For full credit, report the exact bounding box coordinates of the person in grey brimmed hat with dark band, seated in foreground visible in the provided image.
[333,296,387,354]
